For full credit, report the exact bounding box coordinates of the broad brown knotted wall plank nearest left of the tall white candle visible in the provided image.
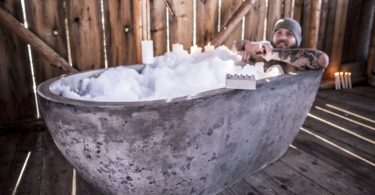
[103,0,136,67]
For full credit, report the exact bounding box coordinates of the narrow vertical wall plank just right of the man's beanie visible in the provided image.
[305,0,322,49]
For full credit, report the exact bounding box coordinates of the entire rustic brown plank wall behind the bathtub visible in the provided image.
[0,0,375,125]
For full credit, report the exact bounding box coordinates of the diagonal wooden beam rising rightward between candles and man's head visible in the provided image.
[211,0,255,47]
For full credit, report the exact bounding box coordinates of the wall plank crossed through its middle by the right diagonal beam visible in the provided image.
[221,0,242,49]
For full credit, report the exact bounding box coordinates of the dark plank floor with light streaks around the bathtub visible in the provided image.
[0,86,375,195]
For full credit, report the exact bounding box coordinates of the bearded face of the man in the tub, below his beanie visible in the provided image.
[272,28,297,49]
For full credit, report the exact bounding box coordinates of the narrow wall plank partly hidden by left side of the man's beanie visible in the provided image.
[266,0,283,40]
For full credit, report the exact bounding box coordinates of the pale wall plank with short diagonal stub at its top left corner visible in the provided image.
[169,0,193,49]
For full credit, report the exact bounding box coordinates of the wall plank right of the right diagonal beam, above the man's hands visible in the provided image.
[245,0,266,41]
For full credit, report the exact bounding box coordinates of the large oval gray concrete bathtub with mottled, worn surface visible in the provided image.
[38,67,322,195]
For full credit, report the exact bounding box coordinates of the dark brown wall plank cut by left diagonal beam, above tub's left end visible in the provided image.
[25,0,68,84]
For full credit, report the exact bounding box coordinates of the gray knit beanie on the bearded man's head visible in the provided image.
[273,18,302,48]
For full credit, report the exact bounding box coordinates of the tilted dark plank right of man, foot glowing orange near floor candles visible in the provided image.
[325,0,349,79]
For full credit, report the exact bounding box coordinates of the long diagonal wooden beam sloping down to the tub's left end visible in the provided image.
[0,8,77,72]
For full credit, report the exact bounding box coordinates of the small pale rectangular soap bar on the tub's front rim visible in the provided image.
[225,74,256,90]
